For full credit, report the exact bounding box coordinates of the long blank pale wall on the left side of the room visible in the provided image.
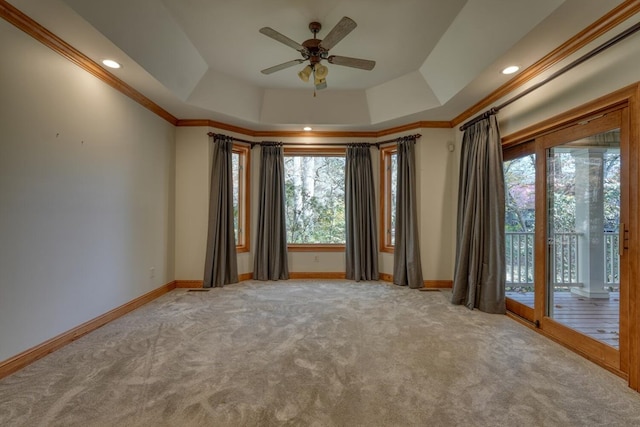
[0,20,175,361]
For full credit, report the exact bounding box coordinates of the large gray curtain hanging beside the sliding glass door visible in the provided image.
[452,115,506,313]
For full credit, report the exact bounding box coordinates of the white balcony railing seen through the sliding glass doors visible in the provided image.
[505,232,620,288]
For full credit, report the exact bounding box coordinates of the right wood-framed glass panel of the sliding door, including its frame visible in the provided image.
[534,110,628,372]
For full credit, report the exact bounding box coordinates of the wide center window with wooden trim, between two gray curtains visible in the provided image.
[284,148,345,251]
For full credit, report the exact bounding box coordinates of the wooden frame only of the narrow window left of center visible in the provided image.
[231,142,251,253]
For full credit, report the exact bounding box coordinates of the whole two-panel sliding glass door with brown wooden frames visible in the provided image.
[504,108,629,372]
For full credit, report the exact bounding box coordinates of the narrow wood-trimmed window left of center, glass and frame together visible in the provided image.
[231,144,251,252]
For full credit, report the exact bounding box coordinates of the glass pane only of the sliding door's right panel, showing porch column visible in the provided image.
[547,133,620,348]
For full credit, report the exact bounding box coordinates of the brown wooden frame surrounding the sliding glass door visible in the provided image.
[502,83,640,391]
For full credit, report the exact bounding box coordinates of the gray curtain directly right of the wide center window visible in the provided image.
[345,144,378,282]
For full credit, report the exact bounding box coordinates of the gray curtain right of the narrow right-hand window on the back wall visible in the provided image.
[393,136,424,288]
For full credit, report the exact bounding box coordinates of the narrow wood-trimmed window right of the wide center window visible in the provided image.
[380,145,398,252]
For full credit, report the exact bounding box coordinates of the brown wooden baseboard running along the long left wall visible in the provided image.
[0,281,176,379]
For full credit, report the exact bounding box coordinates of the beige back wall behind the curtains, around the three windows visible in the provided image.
[175,127,457,280]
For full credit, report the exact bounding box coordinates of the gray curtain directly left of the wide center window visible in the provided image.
[253,143,289,280]
